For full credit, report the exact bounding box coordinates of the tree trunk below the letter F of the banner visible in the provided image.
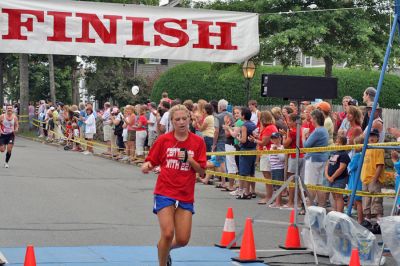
[19,54,29,131]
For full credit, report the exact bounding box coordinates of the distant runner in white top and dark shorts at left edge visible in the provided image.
[0,105,19,168]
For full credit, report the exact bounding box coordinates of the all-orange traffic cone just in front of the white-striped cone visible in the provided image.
[232,218,264,263]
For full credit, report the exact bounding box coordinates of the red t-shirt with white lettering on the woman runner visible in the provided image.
[146,132,207,203]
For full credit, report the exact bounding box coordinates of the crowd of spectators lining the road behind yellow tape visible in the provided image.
[24,87,400,231]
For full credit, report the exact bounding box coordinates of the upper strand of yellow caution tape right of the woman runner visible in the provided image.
[207,142,400,156]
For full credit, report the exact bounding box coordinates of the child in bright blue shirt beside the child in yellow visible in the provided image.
[348,136,364,224]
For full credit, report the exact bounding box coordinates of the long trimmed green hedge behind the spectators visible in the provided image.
[151,63,400,108]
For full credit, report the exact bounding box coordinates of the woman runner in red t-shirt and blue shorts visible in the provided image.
[142,105,207,266]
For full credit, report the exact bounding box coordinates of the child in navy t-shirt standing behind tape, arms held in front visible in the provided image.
[325,136,350,212]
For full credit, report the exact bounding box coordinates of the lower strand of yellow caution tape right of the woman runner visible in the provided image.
[206,170,396,198]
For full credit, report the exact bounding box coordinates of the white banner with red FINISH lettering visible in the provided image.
[0,0,260,62]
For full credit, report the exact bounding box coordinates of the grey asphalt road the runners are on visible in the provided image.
[0,138,394,265]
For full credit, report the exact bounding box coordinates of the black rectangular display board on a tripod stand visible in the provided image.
[261,74,337,100]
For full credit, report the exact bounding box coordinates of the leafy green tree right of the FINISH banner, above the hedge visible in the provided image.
[203,0,389,77]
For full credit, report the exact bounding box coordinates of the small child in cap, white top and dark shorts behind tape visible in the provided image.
[269,132,285,208]
